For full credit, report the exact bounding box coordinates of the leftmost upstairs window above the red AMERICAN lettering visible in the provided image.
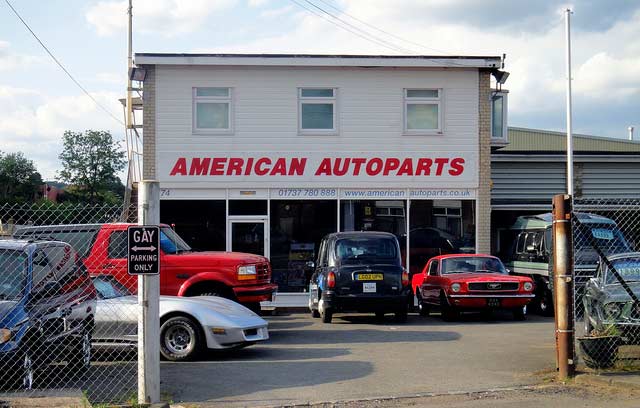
[193,88,231,132]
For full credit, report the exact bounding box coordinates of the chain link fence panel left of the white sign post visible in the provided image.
[0,202,138,403]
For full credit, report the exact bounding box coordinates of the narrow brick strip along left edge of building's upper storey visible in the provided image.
[142,65,157,180]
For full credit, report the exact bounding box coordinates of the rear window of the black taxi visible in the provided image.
[336,237,398,263]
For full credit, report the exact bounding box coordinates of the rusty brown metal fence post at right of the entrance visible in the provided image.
[553,194,575,381]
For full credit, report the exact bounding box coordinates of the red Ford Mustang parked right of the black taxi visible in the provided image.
[411,254,534,320]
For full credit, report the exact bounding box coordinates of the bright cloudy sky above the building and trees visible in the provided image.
[0,0,640,180]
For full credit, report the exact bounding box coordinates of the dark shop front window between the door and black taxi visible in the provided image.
[270,200,337,292]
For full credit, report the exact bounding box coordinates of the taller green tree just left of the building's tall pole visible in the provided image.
[59,130,126,202]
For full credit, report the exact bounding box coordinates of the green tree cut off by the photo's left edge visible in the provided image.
[0,151,42,202]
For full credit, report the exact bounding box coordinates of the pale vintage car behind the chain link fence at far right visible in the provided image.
[583,252,640,344]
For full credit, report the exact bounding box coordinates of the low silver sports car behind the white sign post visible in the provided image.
[92,275,269,361]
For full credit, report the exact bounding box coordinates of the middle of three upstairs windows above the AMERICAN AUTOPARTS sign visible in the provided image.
[298,88,337,133]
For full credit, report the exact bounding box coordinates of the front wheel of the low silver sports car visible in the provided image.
[160,316,203,361]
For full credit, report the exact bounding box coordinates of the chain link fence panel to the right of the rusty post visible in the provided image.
[572,199,640,371]
